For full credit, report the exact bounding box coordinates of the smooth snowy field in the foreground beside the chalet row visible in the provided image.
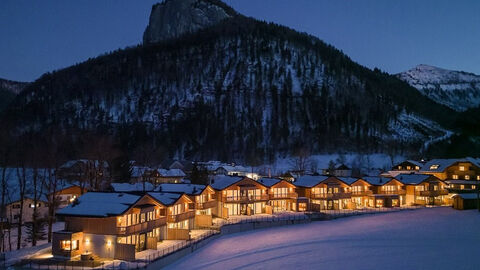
[167,207,480,270]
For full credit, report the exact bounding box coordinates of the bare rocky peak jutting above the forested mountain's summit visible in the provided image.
[143,0,236,44]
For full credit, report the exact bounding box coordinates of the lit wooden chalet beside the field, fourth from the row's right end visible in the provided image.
[295,175,353,211]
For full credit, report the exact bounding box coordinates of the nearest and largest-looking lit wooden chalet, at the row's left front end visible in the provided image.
[52,192,167,260]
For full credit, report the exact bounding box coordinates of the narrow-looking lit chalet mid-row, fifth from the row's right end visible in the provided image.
[258,178,298,213]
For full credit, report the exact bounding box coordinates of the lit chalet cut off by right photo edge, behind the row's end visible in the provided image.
[420,158,480,181]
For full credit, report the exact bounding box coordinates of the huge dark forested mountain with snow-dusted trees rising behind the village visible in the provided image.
[3,0,464,161]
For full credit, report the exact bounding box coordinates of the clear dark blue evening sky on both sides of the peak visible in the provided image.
[0,0,480,81]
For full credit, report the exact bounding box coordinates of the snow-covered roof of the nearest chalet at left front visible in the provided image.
[57,192,141,217]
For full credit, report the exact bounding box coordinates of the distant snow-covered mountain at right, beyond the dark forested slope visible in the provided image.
[397,65,480,112]
